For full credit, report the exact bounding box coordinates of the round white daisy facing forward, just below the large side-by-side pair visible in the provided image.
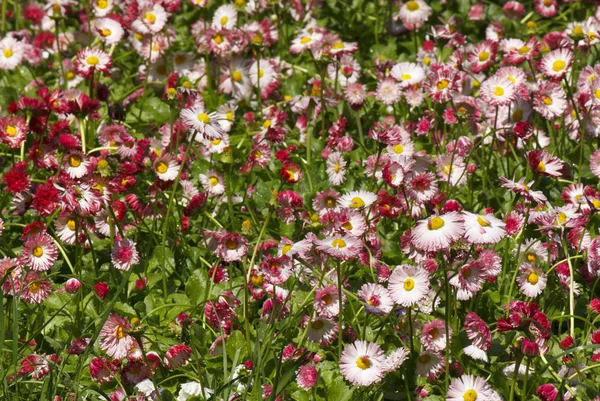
[388,265,429,307]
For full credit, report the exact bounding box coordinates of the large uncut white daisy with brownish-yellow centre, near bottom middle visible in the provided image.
[340,341,385,386]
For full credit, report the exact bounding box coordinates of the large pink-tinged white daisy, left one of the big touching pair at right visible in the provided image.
[411,212,464,252]
